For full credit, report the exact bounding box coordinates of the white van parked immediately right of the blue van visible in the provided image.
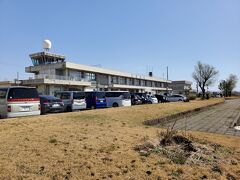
[106,91,131,107]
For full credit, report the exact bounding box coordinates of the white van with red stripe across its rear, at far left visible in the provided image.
[0,86,40,118]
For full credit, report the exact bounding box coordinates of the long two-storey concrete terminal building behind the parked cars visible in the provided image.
[21,51,171,95]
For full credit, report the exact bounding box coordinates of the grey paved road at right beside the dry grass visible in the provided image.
[161,99,240,136]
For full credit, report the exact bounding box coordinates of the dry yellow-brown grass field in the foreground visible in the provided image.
[0,99,240,180]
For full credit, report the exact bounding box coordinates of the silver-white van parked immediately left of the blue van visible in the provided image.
[55,91,87,112]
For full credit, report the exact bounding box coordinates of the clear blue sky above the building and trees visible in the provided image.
[0,0,240,90]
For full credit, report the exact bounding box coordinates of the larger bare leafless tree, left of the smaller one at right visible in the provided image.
[192,61,218,99]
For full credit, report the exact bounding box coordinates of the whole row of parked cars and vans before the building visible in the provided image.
[0,87,187,118]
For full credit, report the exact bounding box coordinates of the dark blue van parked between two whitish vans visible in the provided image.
[85,91,107,109]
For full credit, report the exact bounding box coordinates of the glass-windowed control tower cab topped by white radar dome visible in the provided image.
[29,40,65,66]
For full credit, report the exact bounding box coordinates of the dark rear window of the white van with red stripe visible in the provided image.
[8,88,39,99]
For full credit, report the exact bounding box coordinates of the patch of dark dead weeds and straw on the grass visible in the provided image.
[134,129,232,166]
